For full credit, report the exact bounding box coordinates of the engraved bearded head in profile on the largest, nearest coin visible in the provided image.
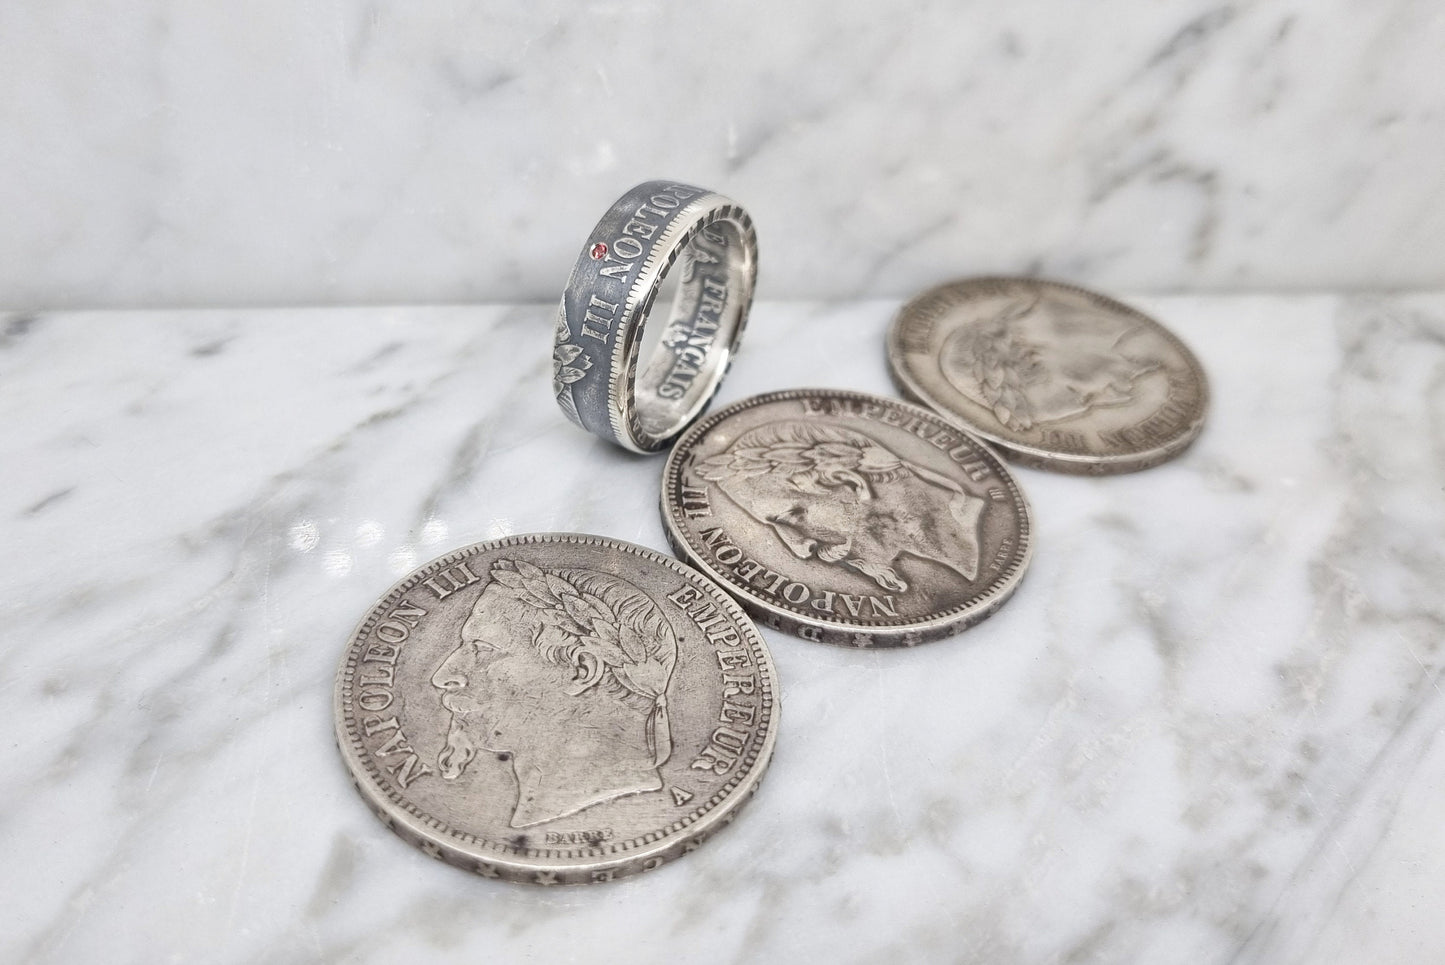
[432,559,678,828]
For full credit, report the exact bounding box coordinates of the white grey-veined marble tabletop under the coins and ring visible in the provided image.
[0,293,1445,965]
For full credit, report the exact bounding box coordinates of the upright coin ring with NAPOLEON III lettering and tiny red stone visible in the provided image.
[552,181,757,452]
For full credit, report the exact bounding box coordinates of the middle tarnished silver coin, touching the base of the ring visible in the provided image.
[662,389,1033,647]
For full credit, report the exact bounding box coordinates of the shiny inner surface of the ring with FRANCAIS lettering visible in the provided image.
[634,221,747,438]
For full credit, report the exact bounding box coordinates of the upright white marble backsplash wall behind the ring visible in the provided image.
[0,0,1445,309]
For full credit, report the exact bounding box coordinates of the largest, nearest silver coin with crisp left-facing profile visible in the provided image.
[335,533,777,884]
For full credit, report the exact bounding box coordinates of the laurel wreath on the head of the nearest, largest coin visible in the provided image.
[491,559,672,764]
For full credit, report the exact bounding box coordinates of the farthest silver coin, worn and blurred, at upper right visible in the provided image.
[887,277,1209,475]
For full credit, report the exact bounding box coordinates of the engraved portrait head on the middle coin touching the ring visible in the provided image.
[695,419,987,592]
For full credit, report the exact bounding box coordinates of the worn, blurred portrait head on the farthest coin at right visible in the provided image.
[939,296,1162,430]
